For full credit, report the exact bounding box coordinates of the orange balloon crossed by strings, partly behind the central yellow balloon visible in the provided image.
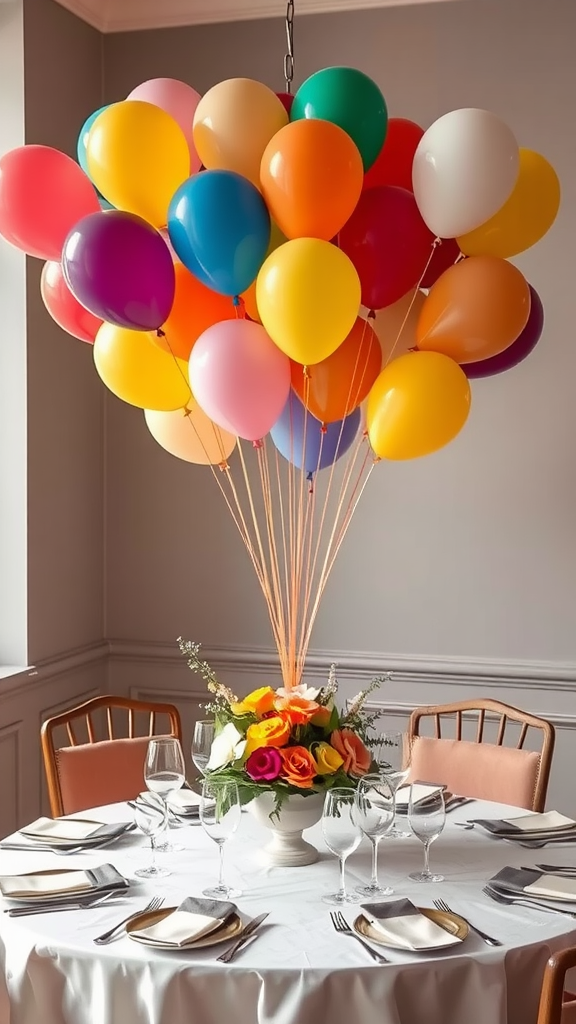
[290,316,382,423]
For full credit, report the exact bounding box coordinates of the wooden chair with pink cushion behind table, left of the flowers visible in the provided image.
[40,696,181,817]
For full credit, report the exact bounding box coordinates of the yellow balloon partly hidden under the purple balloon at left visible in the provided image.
[93,323,192,412]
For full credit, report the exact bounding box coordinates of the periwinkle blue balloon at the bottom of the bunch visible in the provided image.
[270,391,361,474]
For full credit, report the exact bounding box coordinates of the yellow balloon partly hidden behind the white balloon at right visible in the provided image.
[456,150,560,259]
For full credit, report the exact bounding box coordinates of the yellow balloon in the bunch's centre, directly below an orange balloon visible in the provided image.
[256,239,361,366]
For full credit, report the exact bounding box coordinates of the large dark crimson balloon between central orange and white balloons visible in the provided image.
[338,185,434,309]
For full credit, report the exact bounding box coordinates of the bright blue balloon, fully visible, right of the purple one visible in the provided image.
[168,171,270,295]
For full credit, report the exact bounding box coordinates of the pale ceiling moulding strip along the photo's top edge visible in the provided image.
[53,0,457,32]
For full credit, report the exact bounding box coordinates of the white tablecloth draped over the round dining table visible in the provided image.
[0,802,576,1024]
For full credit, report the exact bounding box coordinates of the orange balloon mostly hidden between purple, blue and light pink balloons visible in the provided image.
[151,263,236,359]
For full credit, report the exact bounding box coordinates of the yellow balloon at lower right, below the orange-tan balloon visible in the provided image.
[366,352,470,460]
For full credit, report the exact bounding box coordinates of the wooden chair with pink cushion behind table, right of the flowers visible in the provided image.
[408,697,554,811]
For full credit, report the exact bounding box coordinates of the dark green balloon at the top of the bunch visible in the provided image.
[290,68,388,171]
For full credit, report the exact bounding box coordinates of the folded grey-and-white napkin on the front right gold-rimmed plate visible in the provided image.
[362,899,461,950]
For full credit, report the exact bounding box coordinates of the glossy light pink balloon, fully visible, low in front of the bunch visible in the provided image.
[190,319,290,441]
